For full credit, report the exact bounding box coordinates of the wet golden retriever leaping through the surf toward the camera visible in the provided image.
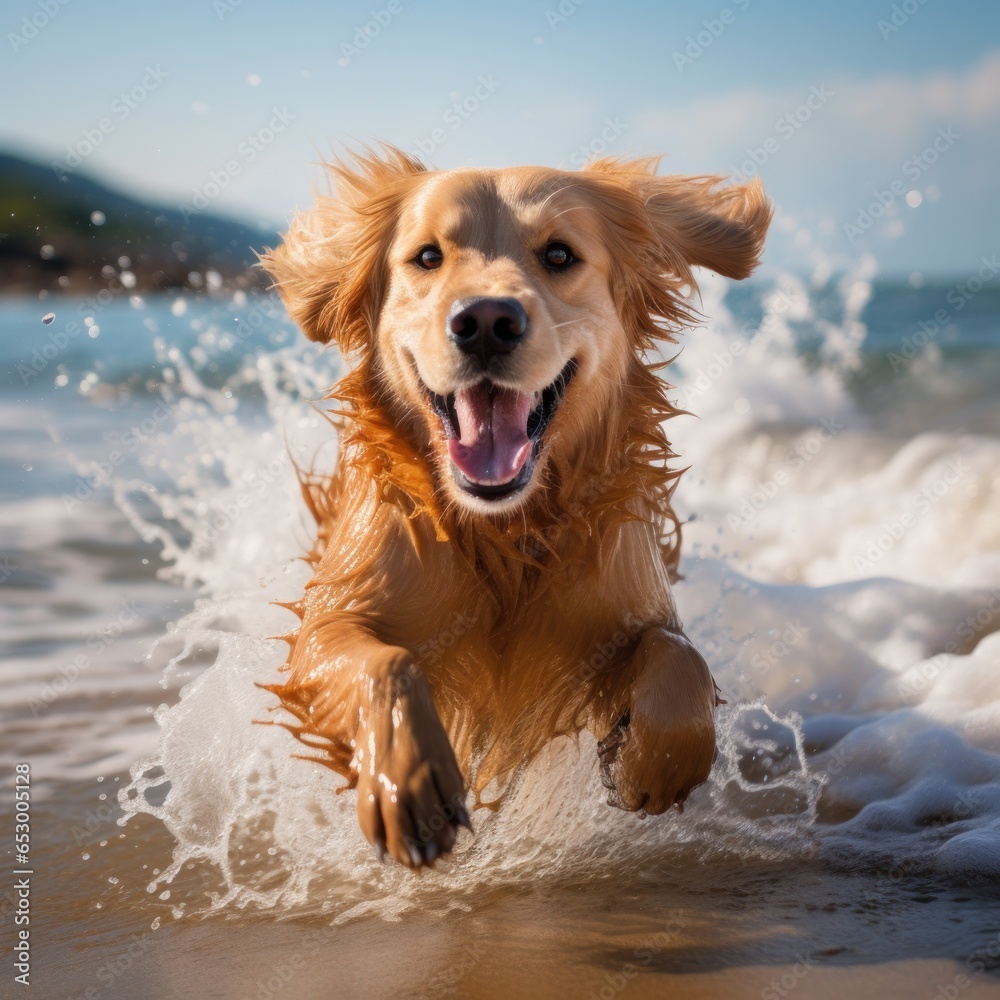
[261,146,772,868]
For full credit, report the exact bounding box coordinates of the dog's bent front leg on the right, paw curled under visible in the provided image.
[597,627,718,813]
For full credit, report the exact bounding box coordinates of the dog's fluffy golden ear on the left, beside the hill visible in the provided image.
[260,146,427,354]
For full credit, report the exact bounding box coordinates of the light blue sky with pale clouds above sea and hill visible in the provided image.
[0,0,1000,276]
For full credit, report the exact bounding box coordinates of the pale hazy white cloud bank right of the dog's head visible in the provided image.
[628,51,1000,270]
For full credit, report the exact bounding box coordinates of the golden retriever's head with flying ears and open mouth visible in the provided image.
[263,149,771,514]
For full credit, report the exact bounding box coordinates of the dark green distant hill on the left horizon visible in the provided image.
[0,153,278,292]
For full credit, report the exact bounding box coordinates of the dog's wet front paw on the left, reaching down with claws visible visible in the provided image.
[357,676,472,868]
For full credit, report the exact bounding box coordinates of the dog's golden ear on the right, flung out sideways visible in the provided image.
[587,159,773,280]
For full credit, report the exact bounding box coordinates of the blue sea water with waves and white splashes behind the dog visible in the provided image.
[0,262,1000,992]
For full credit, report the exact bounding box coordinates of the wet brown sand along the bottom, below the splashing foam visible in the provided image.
[21,777,1000,1000]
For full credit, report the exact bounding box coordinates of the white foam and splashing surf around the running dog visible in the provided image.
[118,269,1000,919]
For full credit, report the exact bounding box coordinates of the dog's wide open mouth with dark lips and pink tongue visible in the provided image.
[428,359,576,500]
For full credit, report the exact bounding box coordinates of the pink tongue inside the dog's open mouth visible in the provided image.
[448,382,533,486]
